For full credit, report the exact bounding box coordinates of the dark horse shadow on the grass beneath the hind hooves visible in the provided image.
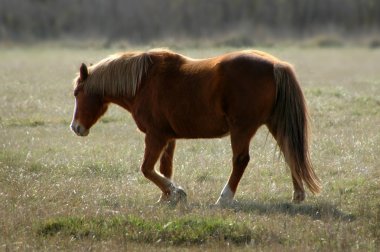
[223,201,356,222]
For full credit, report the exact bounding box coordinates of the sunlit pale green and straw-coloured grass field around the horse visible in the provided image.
[0,46,380,251]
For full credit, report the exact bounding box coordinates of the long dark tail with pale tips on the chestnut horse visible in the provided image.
[267,62,321,194]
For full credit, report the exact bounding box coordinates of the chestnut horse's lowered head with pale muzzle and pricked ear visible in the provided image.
[71,64,108,136]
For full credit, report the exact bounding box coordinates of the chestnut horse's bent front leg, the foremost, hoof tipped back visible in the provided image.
[141,135,186,204]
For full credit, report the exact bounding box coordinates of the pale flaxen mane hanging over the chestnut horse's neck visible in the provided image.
[84,49,156,97]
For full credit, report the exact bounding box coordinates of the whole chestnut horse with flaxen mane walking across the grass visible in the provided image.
[71,49,321,205]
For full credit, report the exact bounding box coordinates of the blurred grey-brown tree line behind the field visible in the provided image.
[0,0,380,42]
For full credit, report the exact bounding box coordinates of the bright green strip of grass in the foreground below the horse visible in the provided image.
[36,215,258,245]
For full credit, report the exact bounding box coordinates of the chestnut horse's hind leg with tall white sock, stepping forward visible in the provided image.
[216,129,257,205]
